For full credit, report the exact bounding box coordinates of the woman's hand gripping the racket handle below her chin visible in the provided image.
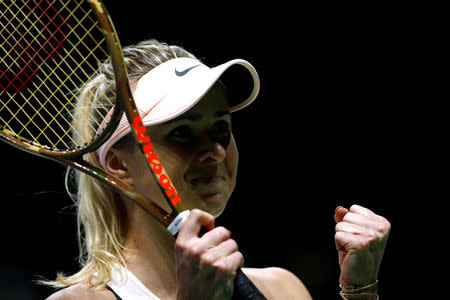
[175,209,244,300]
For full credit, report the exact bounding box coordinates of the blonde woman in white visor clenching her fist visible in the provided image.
[44,40,390,300]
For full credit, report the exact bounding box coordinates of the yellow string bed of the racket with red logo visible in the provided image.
[0,0,115,150]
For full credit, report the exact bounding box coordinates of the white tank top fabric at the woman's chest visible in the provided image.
[108,269,161,300]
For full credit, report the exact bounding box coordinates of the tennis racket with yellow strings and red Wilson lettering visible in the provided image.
[0,0,188,235]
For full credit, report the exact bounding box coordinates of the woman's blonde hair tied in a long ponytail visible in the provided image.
[41,40,195,288]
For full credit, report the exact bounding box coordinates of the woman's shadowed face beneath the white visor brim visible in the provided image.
[118,84,238,216]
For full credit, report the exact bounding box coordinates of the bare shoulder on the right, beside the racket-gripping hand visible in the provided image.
[242,267,312,300]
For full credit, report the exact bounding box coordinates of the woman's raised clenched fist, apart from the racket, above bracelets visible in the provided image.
[334,205,391,286]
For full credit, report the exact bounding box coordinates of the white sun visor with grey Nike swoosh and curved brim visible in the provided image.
[97,57,260,167]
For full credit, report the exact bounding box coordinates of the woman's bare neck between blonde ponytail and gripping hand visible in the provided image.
[125,208,176,299]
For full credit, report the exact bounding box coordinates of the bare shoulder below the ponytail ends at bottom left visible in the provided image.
[46,283,116,300]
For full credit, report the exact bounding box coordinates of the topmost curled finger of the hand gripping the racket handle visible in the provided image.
[178,209,214,240]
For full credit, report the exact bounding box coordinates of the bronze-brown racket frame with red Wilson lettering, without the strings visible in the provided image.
[0,0,189,235]
